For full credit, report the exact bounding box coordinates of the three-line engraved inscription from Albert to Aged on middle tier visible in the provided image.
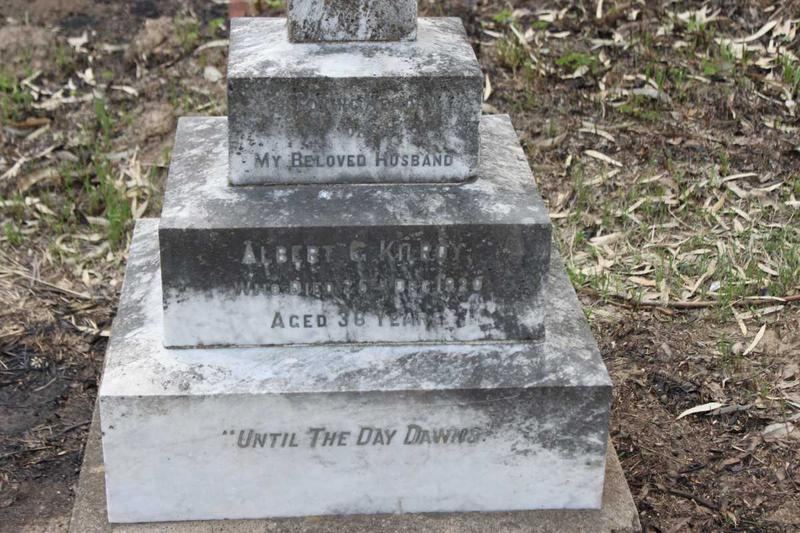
[234,234,493,330]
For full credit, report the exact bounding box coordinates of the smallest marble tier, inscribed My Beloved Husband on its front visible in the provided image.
[228,18,483,185]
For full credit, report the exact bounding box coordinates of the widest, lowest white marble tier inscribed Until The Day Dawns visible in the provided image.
[99,220,611,522]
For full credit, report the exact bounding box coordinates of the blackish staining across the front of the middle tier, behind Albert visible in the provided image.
[161,222,547,340]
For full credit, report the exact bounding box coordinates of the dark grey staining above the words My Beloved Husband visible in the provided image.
[230,78,481,177]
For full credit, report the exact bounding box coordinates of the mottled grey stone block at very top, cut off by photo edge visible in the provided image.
[288,0,417,42]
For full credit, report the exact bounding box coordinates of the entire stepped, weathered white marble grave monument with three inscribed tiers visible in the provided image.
[94,0,611,522]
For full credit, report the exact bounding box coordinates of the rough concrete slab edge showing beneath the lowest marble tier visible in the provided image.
[69,410,641,533]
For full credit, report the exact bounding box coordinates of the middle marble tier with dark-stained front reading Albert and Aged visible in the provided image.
[160,116,551,346]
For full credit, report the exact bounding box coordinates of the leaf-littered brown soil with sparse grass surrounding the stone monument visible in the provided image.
[0,0,800,532]
